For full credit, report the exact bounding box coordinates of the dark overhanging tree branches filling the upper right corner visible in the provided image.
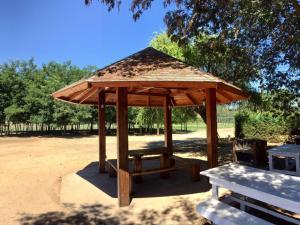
[85,0,300,94]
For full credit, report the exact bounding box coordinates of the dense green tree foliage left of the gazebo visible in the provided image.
[0,59,97,132]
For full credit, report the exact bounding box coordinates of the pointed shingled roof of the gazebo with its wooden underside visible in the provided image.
[52,47,248,106]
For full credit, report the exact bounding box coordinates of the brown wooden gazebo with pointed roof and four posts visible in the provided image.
[52,47,248,206]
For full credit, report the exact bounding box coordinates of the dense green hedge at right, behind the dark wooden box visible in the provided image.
[235,112,292,142]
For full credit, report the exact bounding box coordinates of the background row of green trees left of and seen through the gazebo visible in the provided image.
[0,60,233,135]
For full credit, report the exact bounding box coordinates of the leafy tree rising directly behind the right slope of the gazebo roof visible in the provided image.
[150,33,258,124]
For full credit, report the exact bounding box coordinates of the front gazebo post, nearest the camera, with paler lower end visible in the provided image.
[116,87,131,207]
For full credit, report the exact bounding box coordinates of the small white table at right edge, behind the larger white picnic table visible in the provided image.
[268,144,300,176]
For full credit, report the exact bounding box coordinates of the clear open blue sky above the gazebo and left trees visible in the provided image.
[0,0,169,68]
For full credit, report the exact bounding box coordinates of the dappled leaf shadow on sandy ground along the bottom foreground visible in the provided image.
[19,198,208,225]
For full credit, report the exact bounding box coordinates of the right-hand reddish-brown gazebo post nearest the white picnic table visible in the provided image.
[205,88,218,168]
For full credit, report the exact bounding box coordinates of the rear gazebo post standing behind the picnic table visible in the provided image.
[160,96,173,178]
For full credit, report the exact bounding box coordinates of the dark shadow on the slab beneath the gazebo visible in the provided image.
[76,160,210,198]
